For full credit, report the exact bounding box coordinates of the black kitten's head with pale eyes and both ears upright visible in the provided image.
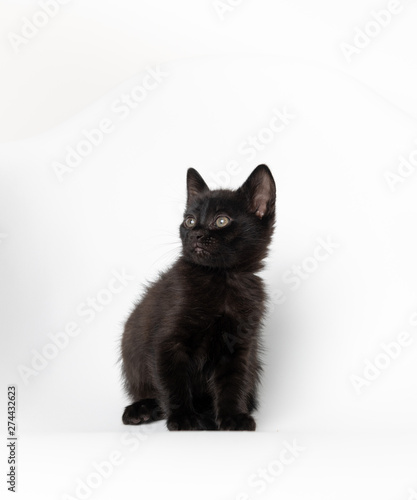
[180,165,275,271]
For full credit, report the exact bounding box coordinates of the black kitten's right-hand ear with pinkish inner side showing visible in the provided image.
[239,165,276,219]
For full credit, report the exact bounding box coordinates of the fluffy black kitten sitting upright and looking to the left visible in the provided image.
[122,165,275,430]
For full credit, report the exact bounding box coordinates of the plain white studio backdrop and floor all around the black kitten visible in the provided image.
[0,0,417,500]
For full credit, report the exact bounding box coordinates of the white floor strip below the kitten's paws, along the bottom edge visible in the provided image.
[19,429,417,500]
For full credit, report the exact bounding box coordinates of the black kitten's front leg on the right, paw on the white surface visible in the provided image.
[213,349,256,431]
